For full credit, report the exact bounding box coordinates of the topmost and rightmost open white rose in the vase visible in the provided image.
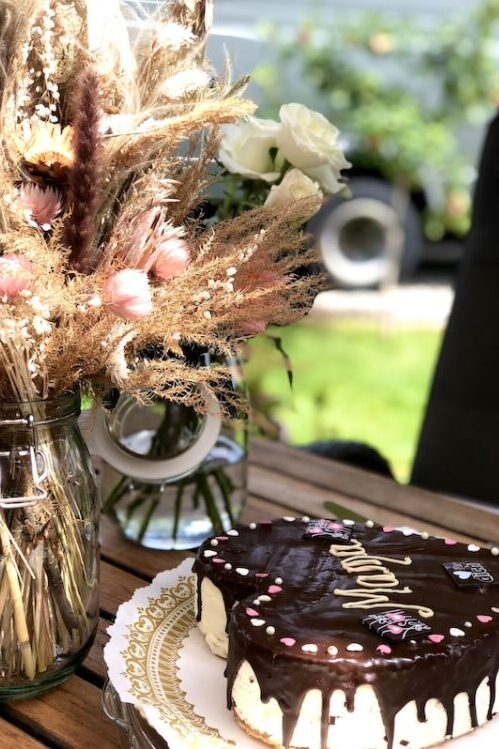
[278,104,351,193]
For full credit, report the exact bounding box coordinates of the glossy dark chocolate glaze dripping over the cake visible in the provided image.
[194,518,499,749]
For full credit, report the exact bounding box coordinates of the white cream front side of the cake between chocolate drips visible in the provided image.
[232,661,499,749]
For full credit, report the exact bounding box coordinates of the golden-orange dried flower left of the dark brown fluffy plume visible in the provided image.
[16,120,74,179]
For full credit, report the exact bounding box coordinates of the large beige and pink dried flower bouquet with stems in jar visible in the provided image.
[0,0,348,685]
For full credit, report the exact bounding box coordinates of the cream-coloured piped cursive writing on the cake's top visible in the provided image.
[329,539,435,619]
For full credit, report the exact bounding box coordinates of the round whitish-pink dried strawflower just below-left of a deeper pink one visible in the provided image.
[103,268,153,320]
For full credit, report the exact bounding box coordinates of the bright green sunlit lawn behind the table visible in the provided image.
[247,322,441,481]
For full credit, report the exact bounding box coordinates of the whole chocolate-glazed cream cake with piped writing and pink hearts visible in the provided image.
[194,517,499,749]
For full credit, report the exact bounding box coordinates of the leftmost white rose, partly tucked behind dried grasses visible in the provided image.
[218,117,281,182]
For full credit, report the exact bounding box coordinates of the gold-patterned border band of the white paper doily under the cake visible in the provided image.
[121,576,236,749]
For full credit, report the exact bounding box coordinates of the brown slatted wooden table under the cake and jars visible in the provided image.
[0,442,499,749]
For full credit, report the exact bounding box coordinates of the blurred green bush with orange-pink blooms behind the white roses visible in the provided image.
[257,0,499,239]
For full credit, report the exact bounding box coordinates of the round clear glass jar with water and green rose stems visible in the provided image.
[99,364,247,550]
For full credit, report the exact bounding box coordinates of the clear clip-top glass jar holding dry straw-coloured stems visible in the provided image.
[0,393,99,701]
